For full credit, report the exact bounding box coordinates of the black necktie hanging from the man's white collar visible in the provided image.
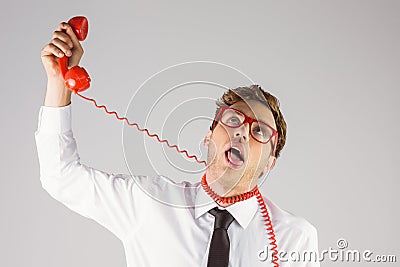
[207,207,234,267]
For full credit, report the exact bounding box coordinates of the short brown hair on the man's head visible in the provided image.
[210,84,286,158]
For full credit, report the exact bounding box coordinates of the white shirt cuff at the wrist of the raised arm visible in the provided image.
[37,103,72,133]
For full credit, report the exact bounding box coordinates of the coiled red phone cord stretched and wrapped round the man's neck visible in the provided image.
[74,91,279,267]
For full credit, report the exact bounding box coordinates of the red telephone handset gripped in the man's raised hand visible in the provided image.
[58,16,91,94]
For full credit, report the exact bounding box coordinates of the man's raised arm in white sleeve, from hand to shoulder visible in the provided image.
[35,22,145,243]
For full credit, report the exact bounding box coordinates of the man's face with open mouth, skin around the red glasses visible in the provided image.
[205,100,277,192]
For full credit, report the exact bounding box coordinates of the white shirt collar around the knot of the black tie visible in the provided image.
[194,184,258,229]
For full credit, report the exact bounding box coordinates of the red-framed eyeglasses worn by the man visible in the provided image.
[213,106,278,155]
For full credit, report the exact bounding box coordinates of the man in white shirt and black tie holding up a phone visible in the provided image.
[35,20,319,267]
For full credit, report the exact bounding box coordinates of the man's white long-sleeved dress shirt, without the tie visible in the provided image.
[35,104,319,267]
